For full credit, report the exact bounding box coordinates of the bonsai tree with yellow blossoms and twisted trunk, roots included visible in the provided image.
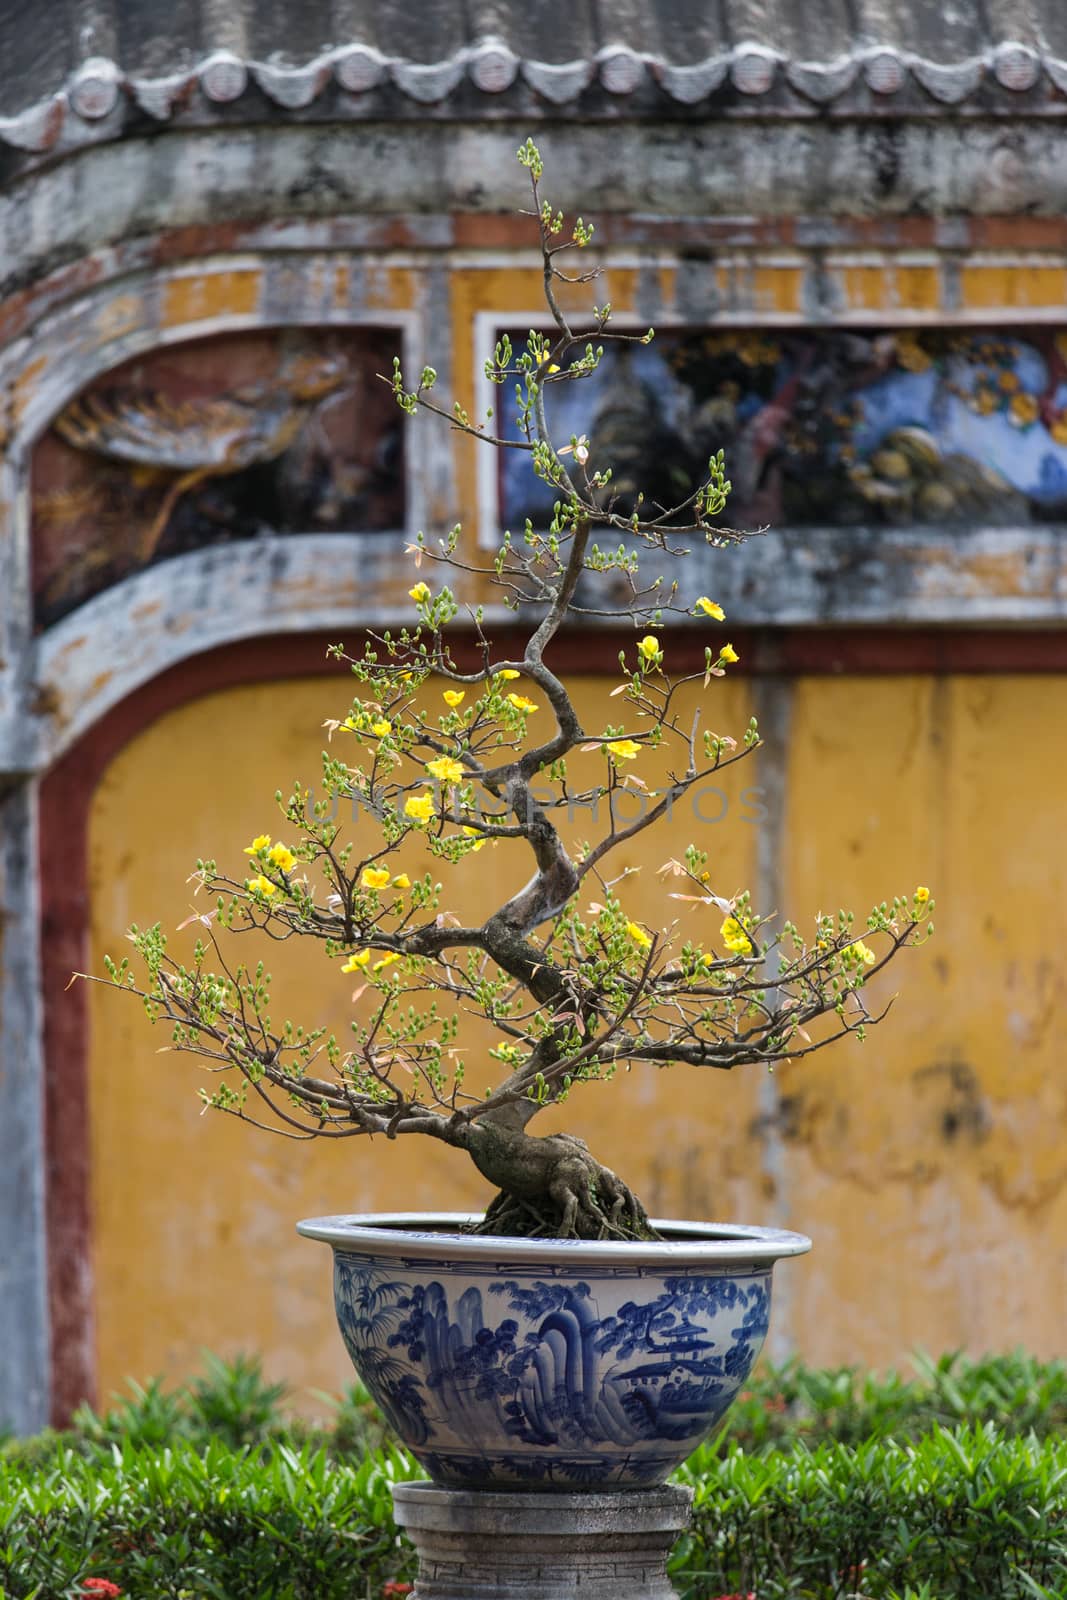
[91,141,933,1240]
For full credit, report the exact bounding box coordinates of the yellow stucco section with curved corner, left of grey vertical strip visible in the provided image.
[90,672,771,1395]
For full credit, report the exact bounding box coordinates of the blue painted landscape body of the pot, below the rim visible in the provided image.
[334,1251,771,1488]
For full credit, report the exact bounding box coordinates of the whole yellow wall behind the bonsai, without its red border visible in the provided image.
[91,677,1067,1392]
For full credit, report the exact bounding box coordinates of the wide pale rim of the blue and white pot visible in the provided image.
[296,1211,811,1270]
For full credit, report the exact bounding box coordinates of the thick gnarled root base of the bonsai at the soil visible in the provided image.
[469,1123,661,1240]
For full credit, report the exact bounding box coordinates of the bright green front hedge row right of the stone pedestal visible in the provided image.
[672,1422,1067,1600]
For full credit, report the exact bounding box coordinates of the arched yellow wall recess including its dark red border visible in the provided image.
[42,634,1067,1416]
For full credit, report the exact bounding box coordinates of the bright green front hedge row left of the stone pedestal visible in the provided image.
[0,1440,422,1600]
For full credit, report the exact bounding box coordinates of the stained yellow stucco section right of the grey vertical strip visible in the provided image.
[781,677,1067,1363]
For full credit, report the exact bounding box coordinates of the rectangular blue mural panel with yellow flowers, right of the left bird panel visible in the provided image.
[499,328,1067,528]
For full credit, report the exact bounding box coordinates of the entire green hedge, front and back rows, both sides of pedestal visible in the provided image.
[0,1355,1067,1600]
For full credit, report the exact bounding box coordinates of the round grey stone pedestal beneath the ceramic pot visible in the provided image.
[392,1483,693,1600]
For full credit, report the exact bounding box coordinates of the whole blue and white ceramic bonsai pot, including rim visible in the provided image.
[298,1214,811,1493]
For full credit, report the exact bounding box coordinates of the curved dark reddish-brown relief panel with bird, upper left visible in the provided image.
[32,328,405,627]
